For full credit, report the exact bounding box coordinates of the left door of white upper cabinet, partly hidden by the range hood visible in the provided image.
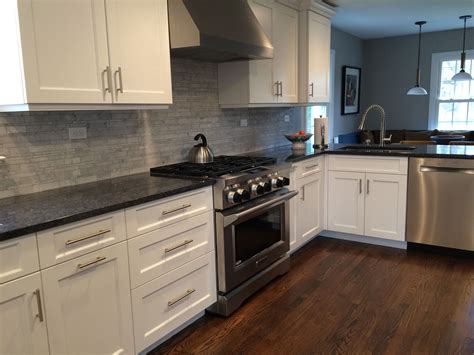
[246,0,277,103]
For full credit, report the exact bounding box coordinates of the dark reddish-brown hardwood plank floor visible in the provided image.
[150,238,474,355]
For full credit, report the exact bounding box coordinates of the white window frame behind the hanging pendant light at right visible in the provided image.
[428,50,474,129]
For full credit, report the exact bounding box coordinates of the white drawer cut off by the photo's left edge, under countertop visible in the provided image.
[0,234,39,284]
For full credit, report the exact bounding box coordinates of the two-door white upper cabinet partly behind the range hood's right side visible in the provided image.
[218,0,298,108]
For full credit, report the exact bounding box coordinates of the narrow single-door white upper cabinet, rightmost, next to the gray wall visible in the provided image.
[299,11,331,103]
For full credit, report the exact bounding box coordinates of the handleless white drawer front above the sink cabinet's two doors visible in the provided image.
[329,155,408,175]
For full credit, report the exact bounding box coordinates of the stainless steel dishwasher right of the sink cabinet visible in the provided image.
[407,158,474,251]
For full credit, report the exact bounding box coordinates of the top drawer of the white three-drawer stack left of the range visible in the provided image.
[125,187,213,238]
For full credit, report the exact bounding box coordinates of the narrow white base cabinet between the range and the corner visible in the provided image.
[290,157,325,251]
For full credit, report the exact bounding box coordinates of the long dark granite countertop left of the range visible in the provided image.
[0,173,214,241]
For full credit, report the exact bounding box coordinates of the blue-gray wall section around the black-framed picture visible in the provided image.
[331,27,365,136]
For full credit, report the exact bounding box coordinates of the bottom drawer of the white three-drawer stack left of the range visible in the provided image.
[132,252,217,353]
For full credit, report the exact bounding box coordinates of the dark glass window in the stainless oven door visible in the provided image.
[234,205,283,265]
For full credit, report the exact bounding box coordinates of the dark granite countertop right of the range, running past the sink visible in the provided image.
[247,143,474,164]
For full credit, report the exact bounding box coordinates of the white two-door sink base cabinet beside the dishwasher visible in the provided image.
[328,156,408,241]
